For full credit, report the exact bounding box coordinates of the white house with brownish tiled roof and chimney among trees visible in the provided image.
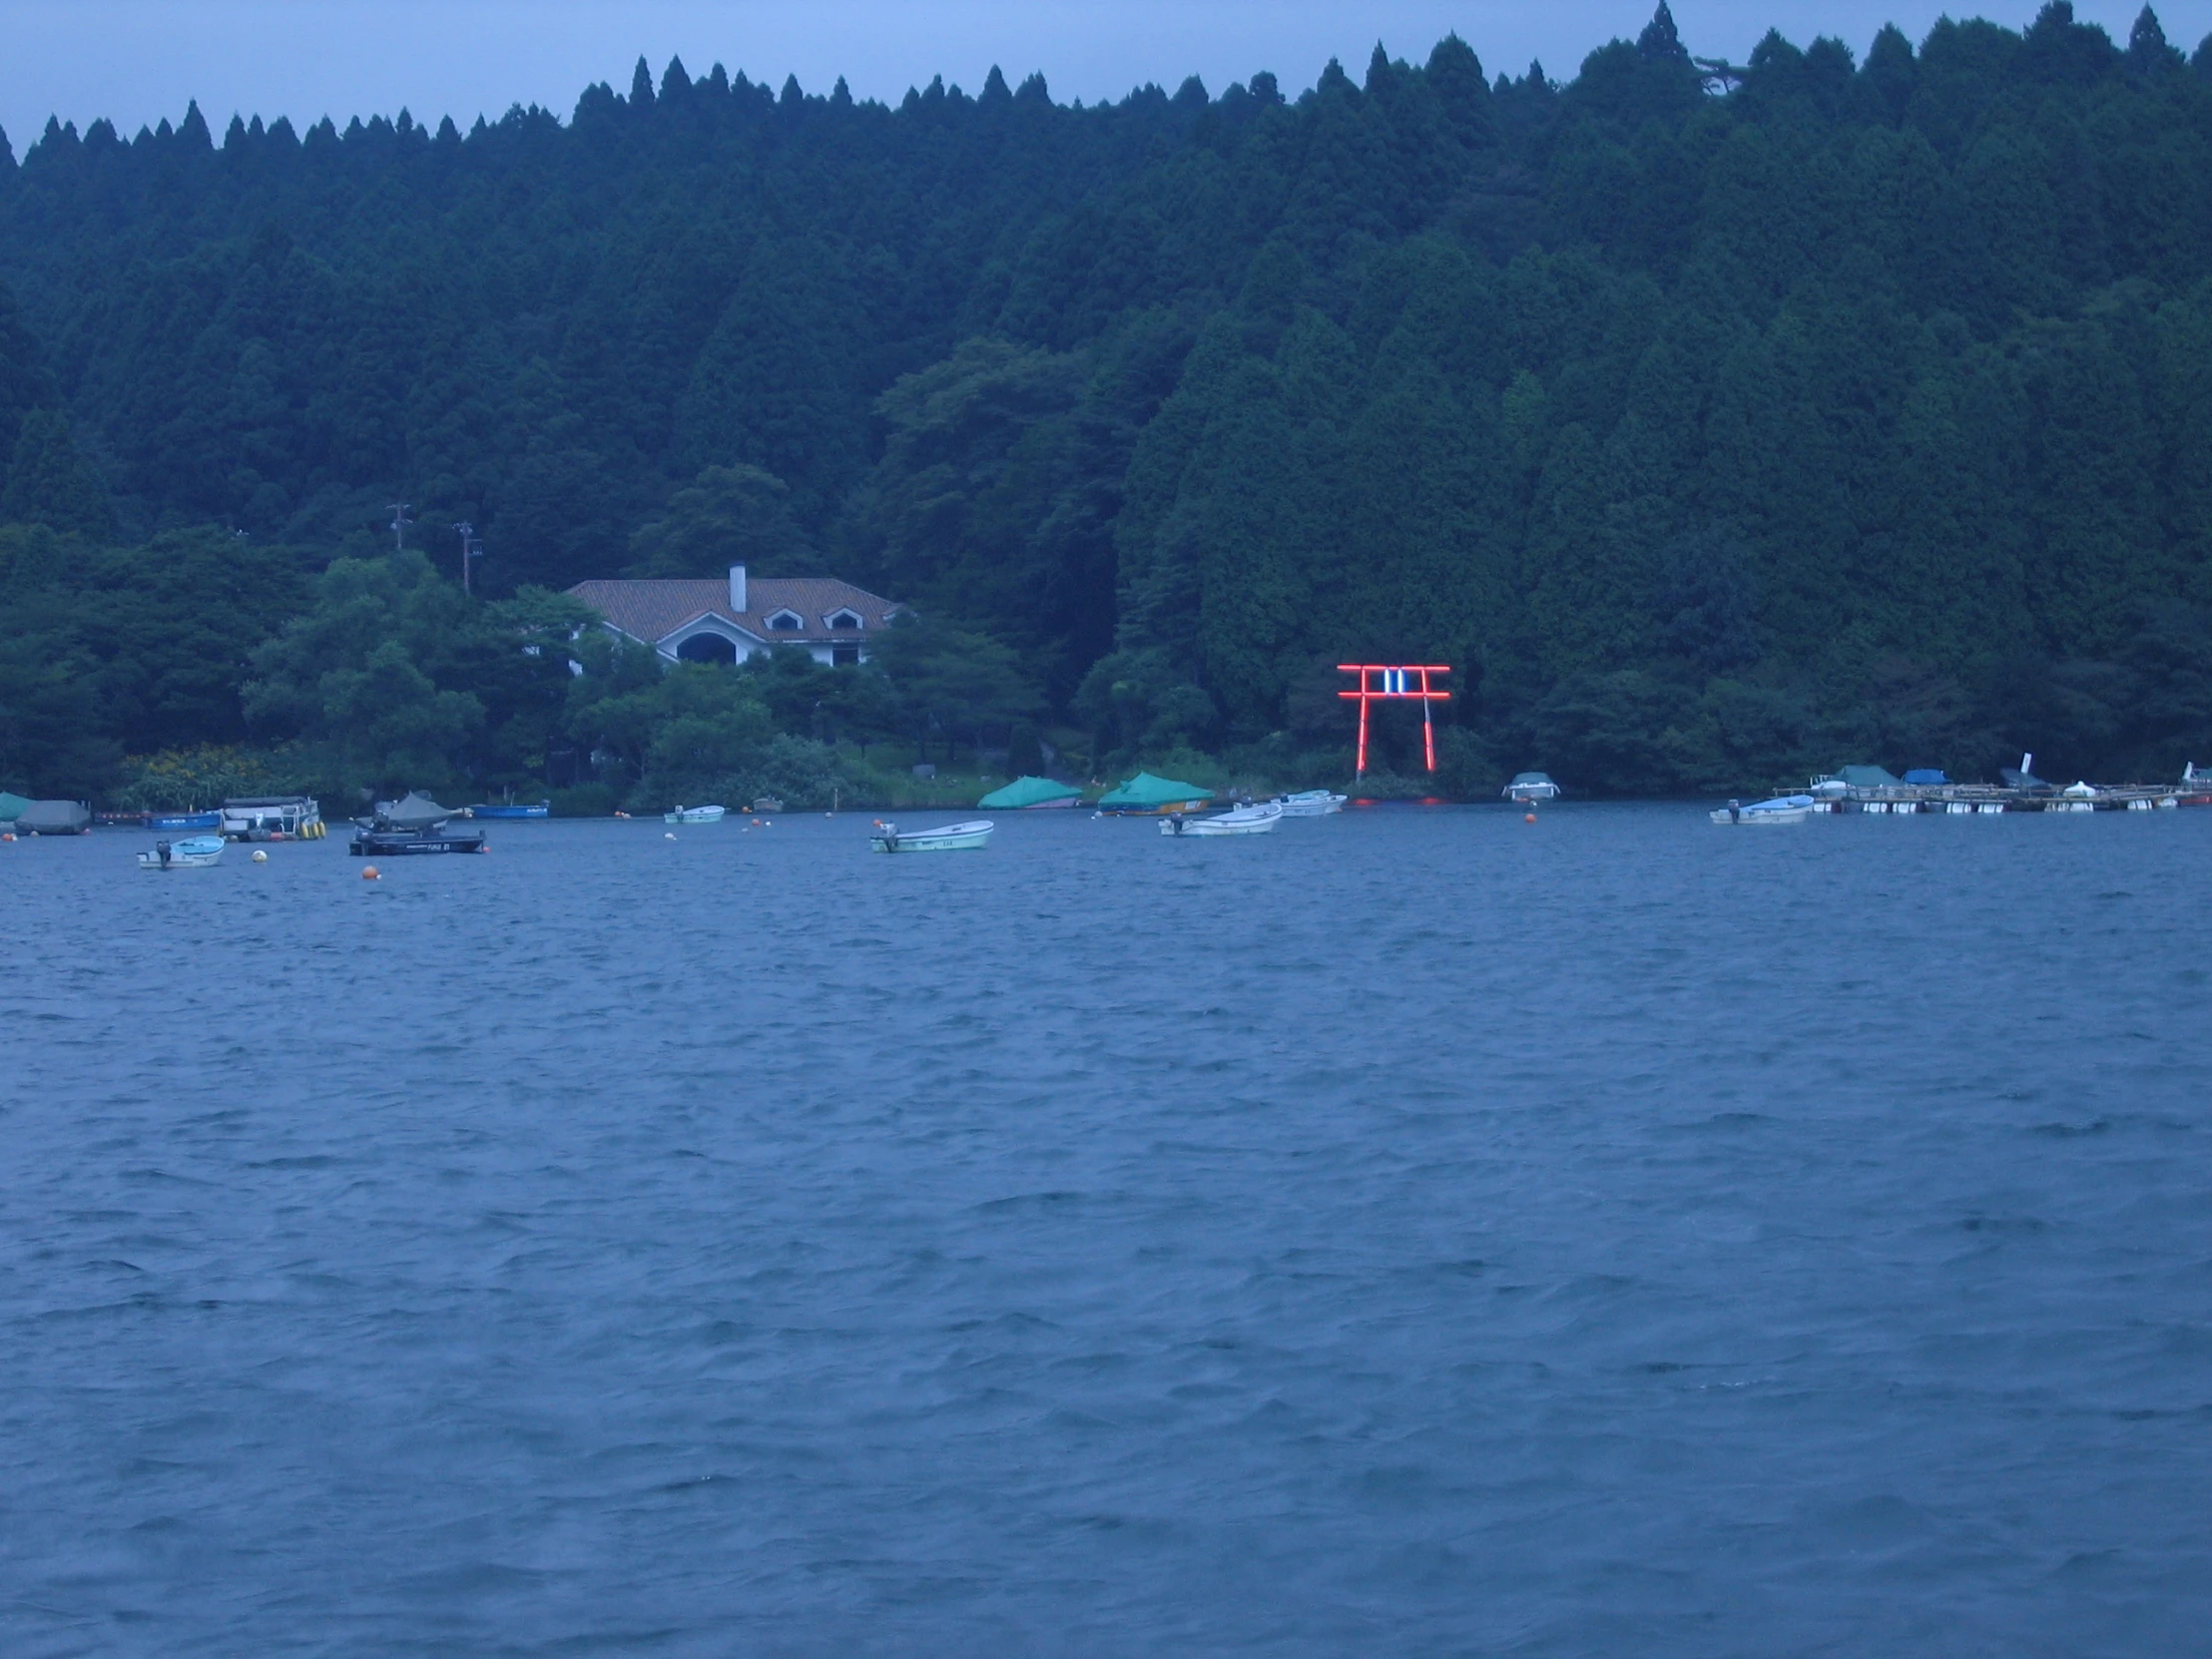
[569,564,900,664]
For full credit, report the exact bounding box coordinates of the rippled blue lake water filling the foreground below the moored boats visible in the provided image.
[0,806,2212,1659]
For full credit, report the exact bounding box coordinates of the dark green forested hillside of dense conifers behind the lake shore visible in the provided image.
[0,2,2212,792]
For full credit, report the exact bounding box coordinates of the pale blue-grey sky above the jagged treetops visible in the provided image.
[0,0,2212,155]
